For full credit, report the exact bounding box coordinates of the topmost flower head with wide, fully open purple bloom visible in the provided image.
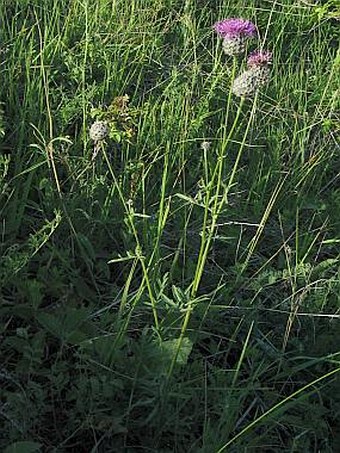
[214,18,257,56]
